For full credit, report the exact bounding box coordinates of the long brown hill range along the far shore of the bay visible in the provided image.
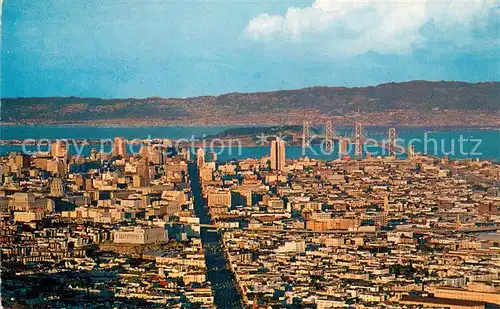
[1,81,500,126]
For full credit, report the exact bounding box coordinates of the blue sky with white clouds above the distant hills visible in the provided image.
[0,0,500,98]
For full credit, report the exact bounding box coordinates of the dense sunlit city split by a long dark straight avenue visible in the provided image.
[0,135,500,309]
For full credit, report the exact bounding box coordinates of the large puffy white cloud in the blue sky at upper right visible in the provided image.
[245,0,498,55]
